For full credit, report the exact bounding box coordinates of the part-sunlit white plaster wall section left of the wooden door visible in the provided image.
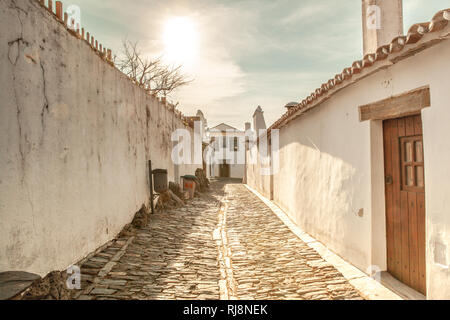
[274,88,370,269]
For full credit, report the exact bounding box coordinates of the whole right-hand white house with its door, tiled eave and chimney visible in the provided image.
[246,0,450,299]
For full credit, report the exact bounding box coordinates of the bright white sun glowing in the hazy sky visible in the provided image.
[164,17,198,65]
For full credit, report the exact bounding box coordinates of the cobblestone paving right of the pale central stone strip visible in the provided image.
[226,184,361,300]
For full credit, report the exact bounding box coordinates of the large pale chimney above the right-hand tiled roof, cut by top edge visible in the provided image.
[362,0,403,55]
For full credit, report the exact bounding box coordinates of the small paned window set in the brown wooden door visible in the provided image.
[400,136,425,192]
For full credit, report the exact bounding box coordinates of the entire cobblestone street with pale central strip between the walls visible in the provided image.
[73,181,361,300]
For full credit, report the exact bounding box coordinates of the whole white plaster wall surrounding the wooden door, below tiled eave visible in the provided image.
[247,41,450,299]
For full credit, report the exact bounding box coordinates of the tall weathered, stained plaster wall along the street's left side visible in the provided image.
[0,0,201,275]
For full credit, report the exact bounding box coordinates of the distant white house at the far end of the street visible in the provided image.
[207,123,245,179]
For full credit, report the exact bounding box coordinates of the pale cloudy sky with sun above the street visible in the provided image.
[63,0,450,128]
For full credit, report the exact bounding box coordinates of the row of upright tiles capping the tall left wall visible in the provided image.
[35,0,189,127]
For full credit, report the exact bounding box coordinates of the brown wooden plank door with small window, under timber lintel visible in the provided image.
[383,115,426,295]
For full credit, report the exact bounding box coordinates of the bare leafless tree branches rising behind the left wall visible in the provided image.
[116,40,193,97]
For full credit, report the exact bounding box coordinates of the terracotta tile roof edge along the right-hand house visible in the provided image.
[269,8,450,131]
